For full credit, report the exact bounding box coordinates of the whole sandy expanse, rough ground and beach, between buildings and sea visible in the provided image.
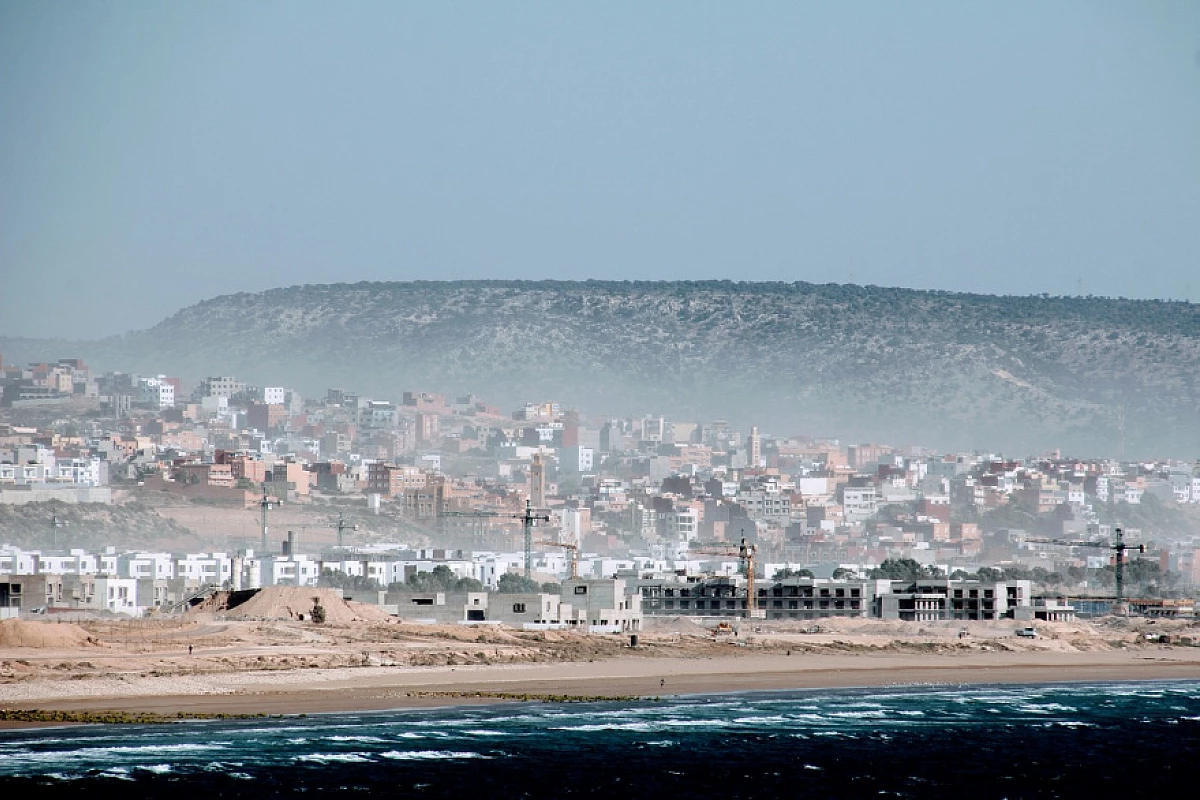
[7,620,1200,726]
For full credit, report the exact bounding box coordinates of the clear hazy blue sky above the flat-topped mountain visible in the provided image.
[0,0,1200,337]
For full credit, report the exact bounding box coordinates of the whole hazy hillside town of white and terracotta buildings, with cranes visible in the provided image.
[0,359,1200,632]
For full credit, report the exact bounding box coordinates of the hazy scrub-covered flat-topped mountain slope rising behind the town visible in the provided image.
[2,281,1200,457]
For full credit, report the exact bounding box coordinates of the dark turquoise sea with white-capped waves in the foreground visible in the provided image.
[0,682,1200,800]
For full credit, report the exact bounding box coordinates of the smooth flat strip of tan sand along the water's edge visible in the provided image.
[0,648,1200,729]
